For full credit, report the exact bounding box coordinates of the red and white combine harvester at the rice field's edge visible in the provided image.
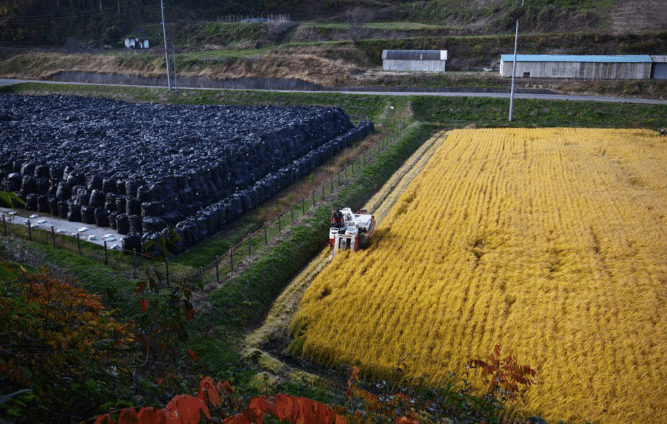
[329,208,375,257]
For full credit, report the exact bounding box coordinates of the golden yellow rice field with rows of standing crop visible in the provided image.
[293,128,667,423]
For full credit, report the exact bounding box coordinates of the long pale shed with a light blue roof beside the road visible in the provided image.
[500,54,654,80]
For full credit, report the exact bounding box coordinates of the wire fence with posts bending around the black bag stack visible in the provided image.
[2,120,406,284]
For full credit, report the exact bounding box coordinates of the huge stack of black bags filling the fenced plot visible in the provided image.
[0,95,373,253]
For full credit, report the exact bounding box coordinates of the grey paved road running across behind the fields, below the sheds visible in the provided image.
[0,79,667,105]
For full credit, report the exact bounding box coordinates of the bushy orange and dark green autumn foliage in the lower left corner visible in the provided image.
[0,261,134,422]
